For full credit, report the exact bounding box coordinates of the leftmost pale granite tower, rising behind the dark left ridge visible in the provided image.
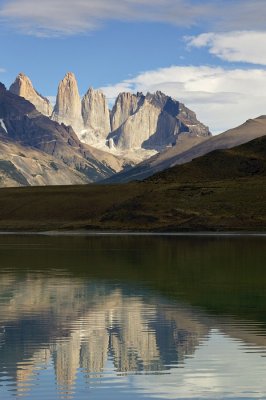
[9,73,53,116]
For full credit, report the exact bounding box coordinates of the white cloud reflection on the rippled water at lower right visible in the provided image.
[130,329,266,400]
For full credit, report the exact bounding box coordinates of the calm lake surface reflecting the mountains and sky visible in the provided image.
[0,236,266,400]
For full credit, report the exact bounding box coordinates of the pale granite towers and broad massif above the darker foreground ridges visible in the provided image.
[8,72,211,164]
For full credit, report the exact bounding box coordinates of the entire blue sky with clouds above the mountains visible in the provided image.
[0,0,266,133]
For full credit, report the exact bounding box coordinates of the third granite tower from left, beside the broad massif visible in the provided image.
[79,88,111,144]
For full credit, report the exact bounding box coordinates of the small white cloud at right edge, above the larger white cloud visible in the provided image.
[187,31,266,65]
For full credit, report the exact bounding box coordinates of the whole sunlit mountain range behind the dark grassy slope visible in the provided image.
[0,73,266,187]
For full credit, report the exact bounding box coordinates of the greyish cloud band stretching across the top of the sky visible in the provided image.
[0,0,266,36]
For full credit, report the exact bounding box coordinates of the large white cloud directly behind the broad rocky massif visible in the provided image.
[101,66,266,133]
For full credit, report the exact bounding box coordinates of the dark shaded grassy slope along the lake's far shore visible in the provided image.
[0,137,266,231]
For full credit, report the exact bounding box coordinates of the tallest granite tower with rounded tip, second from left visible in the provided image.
[52,72,83,132]
